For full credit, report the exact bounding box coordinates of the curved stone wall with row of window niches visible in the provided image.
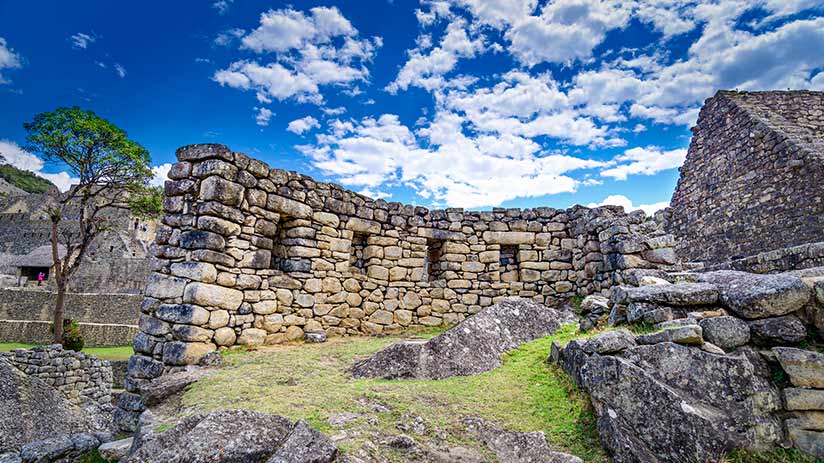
[125,145,675,377]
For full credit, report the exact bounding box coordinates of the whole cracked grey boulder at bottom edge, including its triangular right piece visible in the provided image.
[120,410,337,463]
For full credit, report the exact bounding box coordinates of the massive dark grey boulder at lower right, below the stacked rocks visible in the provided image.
[562,342,782,463]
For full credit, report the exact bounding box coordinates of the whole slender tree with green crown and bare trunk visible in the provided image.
[23,107,152,343]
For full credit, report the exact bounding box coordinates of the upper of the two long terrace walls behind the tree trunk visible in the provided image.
[0,288,143,324]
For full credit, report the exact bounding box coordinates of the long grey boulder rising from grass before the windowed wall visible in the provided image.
[352,298,566,379]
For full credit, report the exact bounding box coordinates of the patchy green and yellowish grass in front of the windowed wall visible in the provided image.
[183,326,606,462]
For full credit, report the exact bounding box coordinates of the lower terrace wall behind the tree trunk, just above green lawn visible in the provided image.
[0,320,138,347]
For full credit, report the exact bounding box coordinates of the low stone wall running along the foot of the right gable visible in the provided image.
[704,242,824,273]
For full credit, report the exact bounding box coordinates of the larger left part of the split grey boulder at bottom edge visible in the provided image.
[121,410,292,463]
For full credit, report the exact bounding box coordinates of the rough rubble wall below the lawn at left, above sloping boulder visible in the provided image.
[0,344,112,408]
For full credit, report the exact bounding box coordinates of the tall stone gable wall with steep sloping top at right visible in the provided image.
[664,91,824,263]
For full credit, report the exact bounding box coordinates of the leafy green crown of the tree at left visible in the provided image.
[23,106,152,191]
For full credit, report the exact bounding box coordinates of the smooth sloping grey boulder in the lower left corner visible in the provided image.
[0,358,106,454]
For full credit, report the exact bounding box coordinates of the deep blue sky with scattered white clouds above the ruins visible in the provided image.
[0,0,824,212]
